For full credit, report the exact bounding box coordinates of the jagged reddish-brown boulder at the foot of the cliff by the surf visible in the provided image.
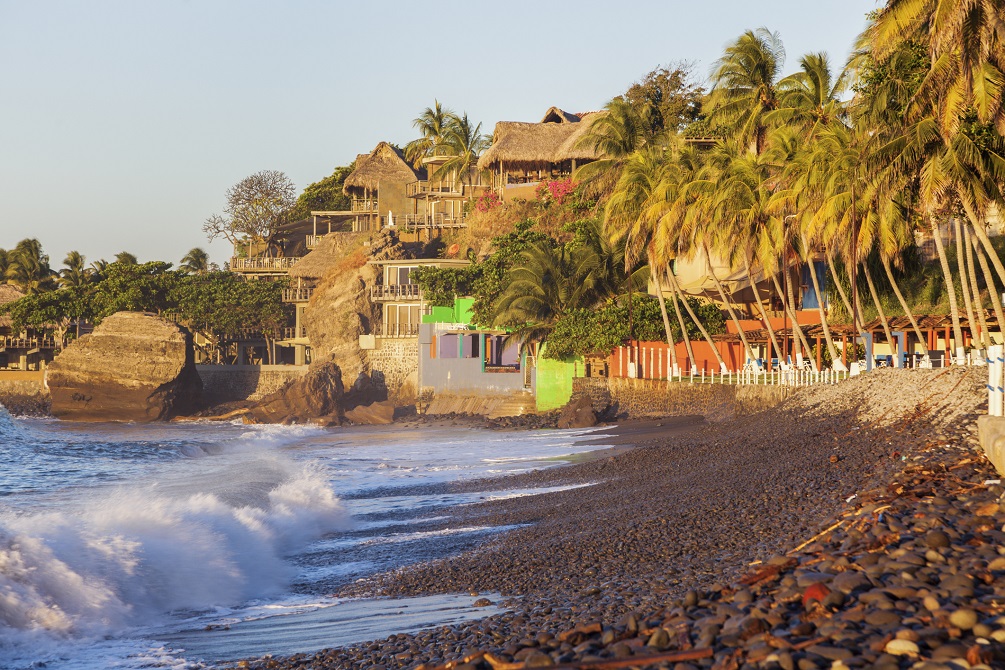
[245,361,345,424]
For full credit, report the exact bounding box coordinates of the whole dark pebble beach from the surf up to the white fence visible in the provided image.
[240,369,1005,670]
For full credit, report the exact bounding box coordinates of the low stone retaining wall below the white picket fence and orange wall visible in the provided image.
[573,377,792,421]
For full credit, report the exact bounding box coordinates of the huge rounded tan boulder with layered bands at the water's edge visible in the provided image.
[46,311,202,422]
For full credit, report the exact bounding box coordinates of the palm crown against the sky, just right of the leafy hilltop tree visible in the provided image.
[709,28,785,154]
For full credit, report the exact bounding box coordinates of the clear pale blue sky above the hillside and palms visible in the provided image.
[0,0,878,267]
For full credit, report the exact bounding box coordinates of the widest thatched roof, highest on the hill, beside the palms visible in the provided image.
[478,107,600,170]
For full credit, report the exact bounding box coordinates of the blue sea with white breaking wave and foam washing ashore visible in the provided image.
[0,407,600,668]
